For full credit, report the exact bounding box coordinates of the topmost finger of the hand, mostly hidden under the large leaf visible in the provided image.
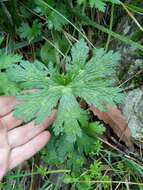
[0,96,16,117]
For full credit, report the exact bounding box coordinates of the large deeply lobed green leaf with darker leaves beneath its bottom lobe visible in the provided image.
[7,39,122,165]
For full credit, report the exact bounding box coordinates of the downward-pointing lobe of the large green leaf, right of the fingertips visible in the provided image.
[53,88,88,142]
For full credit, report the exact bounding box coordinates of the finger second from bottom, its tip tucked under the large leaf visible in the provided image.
[8,110,56,148]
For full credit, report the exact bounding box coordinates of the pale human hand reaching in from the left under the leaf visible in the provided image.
[0,97,56,180]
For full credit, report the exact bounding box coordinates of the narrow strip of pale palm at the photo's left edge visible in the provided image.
[0,122,10,180]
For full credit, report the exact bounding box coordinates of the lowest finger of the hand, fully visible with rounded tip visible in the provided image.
[9,131,50,169]
